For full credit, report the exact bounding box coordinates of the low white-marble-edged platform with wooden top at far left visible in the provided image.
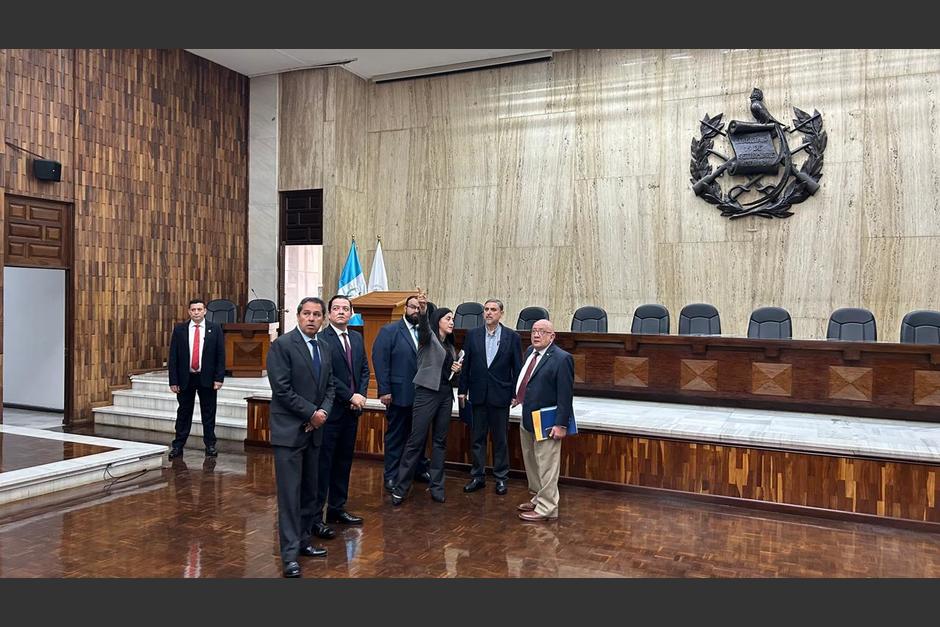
[0,424,167,505]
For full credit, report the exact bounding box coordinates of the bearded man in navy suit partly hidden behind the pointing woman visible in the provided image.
[372,294,431,492]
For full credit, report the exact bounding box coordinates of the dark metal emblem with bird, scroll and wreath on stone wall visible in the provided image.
[690,87,826,220]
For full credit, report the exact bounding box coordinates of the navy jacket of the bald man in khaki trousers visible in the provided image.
[513,344,574,431]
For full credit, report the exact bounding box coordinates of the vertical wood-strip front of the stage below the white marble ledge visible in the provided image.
[356,411,940,523]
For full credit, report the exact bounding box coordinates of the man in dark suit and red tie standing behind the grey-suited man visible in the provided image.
[313,295,369,539]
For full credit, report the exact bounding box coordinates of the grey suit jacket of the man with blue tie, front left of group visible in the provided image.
[267,329,336,446]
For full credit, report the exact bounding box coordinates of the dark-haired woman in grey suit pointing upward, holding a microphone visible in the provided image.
[392,294,461,505]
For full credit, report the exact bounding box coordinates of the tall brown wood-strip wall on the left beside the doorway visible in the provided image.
[3,50,248,421]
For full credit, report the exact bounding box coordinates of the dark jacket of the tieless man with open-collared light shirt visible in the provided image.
[457,324,522,407]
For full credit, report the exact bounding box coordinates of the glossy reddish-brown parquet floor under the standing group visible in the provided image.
[0,432,940,578]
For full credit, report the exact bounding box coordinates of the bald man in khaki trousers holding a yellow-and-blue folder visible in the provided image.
[512,320,574,522]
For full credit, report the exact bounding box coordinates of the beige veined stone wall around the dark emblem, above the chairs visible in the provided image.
[280,50,940,341]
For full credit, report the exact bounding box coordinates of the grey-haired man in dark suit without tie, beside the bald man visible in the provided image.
[457,299,522,495]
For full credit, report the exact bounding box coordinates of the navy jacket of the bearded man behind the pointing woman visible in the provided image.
[372,319,418,407]
